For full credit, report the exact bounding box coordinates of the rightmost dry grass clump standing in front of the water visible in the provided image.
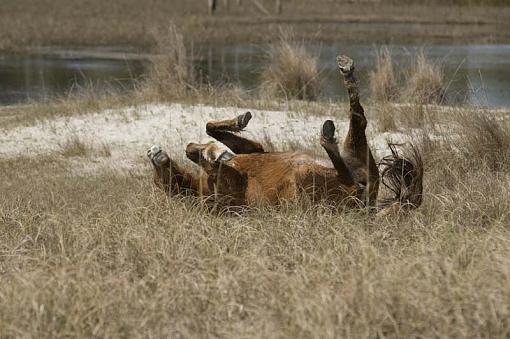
[402,50,445,104]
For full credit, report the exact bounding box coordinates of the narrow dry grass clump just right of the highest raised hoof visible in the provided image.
[369,46,399,102]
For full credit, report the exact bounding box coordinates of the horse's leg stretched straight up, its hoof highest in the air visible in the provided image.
[337,55,379,206]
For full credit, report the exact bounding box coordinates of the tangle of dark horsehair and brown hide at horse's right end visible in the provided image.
[377,143,423,213]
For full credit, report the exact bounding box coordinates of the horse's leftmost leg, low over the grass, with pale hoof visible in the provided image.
[147,145,208,196]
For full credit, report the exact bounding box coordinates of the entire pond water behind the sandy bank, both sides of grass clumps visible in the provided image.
[0,44,510,107]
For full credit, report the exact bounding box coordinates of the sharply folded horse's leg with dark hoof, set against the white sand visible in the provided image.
[206,112,264,154]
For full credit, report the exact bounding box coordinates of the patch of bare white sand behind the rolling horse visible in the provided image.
[0,104,406,174]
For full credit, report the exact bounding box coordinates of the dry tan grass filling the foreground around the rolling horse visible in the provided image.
[0,103,510,338]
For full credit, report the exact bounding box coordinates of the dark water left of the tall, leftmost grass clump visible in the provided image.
[0,51,145,105]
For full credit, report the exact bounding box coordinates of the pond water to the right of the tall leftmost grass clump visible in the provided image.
[200,45,510,107]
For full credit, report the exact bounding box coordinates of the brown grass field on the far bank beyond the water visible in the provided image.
[0,0,510,51]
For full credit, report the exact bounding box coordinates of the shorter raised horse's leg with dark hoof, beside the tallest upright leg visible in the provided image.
[321,120,356,186]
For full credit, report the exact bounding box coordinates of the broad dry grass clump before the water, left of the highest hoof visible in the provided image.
[261,31,321,100]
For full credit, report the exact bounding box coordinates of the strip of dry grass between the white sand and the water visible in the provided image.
[0,84,346,131]
